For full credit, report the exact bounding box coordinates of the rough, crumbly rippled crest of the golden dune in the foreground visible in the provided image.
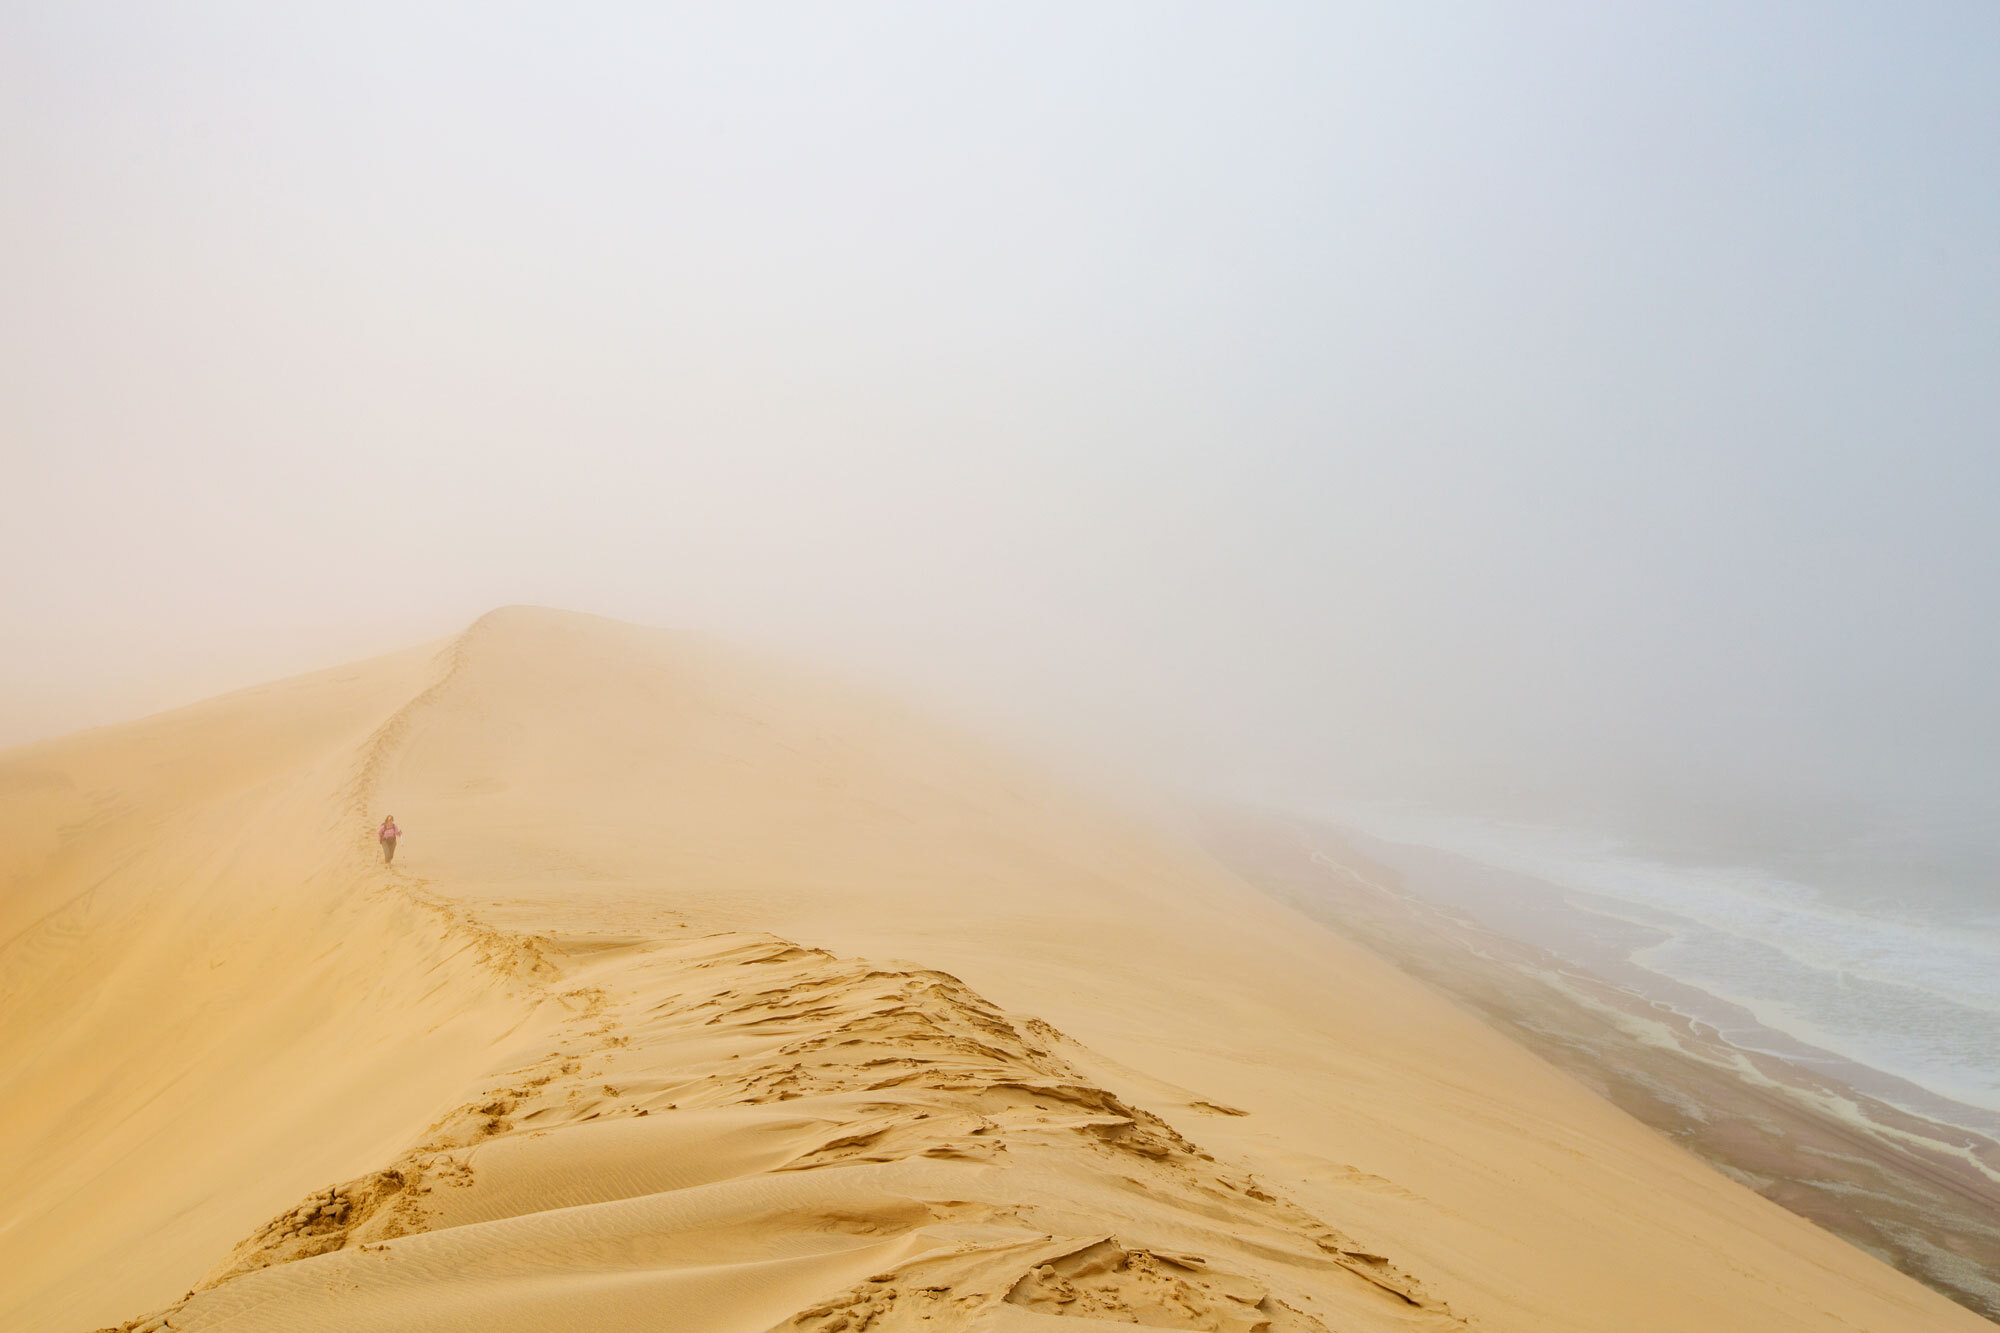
[109,925,1464,1333]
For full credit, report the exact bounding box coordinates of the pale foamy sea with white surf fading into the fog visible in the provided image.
[1334,803,2000,1135]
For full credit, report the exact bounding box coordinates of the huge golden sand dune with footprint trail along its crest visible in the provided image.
[0,608,1988,1333]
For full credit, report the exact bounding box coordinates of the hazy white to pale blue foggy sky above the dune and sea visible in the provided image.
[0,0,2000,840]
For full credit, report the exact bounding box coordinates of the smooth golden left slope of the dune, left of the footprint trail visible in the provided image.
[0,650,544,1329]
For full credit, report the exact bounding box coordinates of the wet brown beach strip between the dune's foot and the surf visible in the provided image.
[1208,813,2000,1321]
